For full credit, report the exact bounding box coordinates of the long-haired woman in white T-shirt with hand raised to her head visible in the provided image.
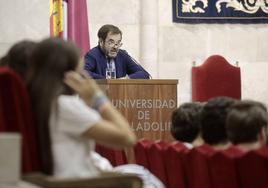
[28,38,163,188]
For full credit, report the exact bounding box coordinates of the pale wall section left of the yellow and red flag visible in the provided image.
[0,0,49,56]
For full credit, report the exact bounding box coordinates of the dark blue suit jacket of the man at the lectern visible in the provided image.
[85,46,150,79]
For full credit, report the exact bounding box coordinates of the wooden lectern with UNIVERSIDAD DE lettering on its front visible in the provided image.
[97,79,178,141]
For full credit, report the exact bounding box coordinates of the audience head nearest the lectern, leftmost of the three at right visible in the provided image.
[171,103,203,143]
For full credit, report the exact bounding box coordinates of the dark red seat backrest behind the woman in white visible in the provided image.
[0,67,40,173]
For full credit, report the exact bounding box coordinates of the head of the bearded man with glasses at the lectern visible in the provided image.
[98,24,122,58]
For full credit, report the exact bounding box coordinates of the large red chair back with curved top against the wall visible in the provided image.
[192,55,241,102]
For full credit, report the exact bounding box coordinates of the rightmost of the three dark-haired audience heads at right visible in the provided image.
[226,100,268,145]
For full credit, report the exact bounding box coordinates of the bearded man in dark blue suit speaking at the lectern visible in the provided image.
[85,24,150,79]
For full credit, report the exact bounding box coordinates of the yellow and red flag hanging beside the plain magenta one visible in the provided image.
[49,0,64,37]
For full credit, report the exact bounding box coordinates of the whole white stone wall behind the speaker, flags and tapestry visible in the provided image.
[0,0,268,104]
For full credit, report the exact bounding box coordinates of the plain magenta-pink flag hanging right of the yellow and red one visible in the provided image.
[67,0,90,55]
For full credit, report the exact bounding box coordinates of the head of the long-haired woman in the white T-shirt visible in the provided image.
[27,38,82,96]
